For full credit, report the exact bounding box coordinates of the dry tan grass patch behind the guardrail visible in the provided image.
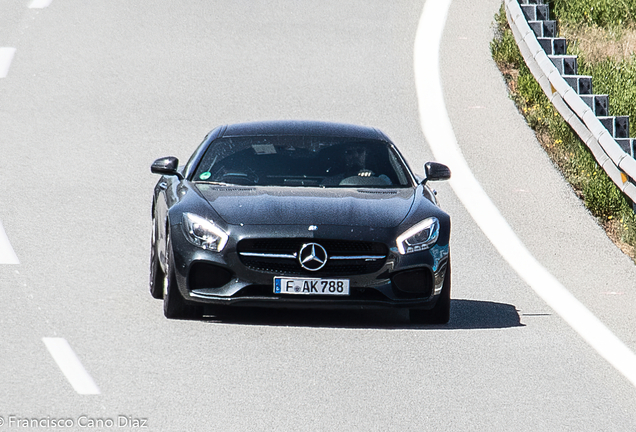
[559,23,636,64]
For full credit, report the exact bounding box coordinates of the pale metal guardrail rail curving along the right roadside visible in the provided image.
[504,0,636,205]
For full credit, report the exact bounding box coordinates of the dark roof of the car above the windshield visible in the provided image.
[219,120,390,142]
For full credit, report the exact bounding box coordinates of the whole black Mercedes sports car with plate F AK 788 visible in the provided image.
[150,121,451,323]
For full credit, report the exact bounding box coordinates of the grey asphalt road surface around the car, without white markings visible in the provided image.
[0,0,636,431]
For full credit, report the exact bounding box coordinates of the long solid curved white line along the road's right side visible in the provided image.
[414,0,636,386]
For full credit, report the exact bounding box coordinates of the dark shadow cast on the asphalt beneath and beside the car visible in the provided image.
[203,299,523,330]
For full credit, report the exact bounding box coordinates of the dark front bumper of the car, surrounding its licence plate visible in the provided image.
[166,226,449,309]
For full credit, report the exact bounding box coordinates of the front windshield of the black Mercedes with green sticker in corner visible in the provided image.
[192,136,411,188]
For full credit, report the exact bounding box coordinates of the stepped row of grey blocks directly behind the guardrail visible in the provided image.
[519,0,636,158]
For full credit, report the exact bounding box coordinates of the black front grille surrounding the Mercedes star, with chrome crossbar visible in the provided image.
[237,238,388,277]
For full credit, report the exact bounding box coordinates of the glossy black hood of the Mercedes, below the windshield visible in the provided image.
[196,184,415,228]
